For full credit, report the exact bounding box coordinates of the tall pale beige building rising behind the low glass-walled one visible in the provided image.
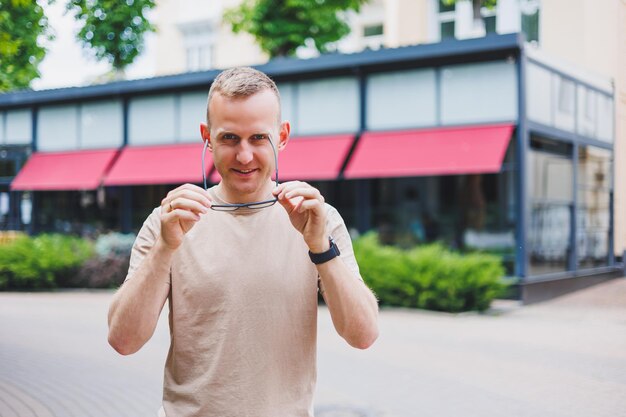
[149,0,626,254]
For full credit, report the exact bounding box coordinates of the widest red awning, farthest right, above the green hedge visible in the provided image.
[344,125,513,178]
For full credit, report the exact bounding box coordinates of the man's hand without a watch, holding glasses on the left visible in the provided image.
[161,184,211,250]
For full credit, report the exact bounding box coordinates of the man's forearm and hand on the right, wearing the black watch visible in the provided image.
[274,181,378,349]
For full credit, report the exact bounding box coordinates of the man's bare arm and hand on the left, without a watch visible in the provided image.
[109,184,211,355]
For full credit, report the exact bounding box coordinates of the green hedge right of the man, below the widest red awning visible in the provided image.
[354,233,506,312]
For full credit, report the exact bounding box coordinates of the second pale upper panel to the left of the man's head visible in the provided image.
[128,94,177,145]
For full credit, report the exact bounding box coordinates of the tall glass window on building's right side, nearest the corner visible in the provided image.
[528,137,574,275]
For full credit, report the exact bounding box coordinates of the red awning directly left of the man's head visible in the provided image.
[104,141,213,186]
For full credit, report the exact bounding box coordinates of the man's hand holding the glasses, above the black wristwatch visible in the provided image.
[272,181,329,253]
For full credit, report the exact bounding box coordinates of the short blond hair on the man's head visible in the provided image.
[206,67,281,127]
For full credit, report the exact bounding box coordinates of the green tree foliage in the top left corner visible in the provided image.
[0,0,52,92]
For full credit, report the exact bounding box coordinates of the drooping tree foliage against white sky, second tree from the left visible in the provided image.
[67,0,155,71]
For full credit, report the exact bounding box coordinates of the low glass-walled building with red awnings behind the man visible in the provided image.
[0,34,621,301]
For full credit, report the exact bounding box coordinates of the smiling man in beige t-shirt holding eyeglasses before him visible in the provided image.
[109,68,378,417]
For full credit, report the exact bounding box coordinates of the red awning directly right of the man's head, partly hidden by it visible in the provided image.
[211,135,354,183]
